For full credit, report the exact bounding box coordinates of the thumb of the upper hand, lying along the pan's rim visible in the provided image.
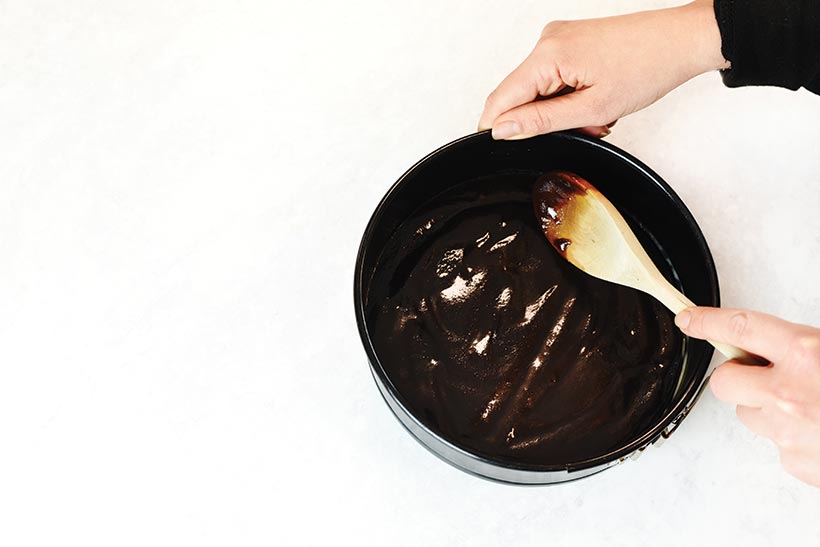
[493,88,612,140]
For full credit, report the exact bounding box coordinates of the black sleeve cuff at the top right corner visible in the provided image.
[714,0,820,94]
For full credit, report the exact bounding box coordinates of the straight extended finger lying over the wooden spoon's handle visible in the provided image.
[675,307,800,362]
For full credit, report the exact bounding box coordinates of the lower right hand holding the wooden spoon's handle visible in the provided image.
[675,307,820,487]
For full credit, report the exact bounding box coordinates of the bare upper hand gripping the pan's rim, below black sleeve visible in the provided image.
[478,0,728,139]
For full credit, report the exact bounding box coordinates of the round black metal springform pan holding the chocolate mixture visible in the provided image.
[354,131,720,484]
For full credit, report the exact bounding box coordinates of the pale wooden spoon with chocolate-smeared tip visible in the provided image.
[533,172,765,364]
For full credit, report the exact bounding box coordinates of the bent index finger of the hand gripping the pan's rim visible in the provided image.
[478,54,564,131]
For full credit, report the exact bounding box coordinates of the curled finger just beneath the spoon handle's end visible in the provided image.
[709,361,773,408]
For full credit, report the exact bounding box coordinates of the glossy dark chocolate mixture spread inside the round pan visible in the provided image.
[367,174,683,465]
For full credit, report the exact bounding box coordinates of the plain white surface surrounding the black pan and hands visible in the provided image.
[0,0,820,546]
